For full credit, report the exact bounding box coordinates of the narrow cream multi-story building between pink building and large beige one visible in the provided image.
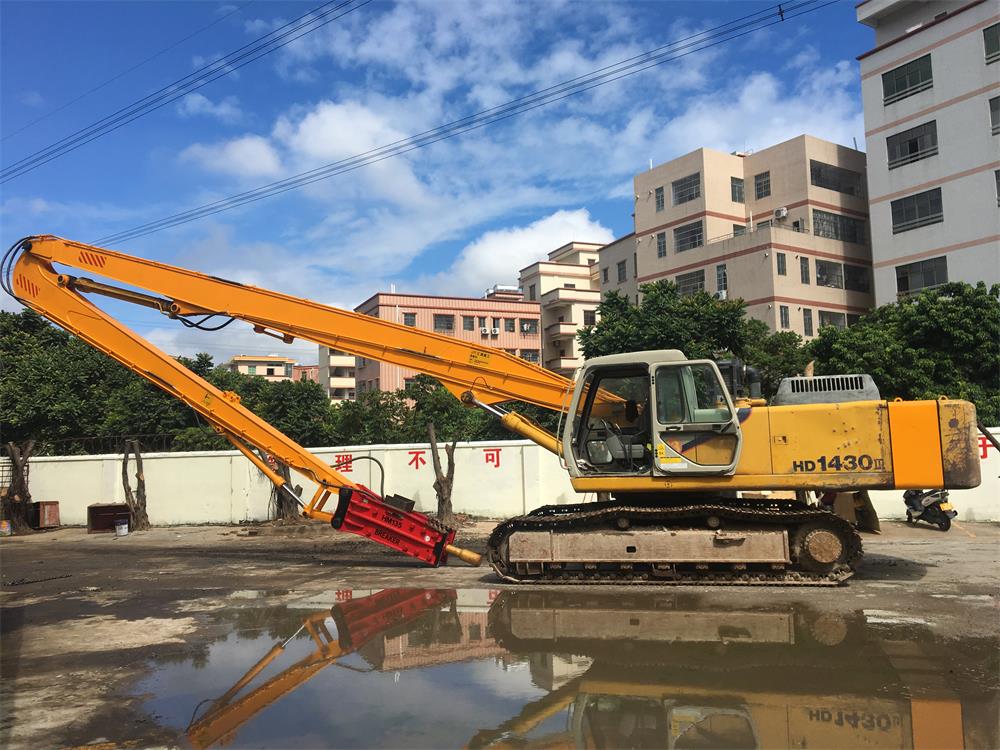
[520,242,601,375]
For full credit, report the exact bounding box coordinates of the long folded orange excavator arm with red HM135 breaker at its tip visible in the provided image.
[0,235,571,565]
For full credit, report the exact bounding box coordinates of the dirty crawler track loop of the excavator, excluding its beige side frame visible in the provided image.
[487,500,861,586]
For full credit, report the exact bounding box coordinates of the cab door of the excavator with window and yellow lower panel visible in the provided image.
[651,360,743,476]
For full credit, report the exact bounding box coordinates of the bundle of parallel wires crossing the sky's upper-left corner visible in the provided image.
[0,0,372,184]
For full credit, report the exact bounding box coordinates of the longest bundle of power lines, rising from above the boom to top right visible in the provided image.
[95,0,837,244]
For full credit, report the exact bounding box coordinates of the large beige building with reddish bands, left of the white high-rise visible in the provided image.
[632,135,874,338]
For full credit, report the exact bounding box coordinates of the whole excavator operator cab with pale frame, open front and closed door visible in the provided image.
[563,350,742,476]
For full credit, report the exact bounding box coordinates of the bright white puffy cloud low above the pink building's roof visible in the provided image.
[418,208,614,295]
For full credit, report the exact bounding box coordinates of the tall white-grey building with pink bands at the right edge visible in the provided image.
[857,0,1000,305]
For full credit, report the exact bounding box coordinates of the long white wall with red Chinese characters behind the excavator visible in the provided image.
[23,428,1000,526]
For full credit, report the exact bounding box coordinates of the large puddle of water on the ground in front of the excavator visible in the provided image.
[139,589,1000,750]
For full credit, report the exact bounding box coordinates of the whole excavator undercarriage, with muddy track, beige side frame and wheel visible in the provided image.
[487,499,861,586]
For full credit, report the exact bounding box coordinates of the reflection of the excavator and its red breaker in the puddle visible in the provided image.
[188,589,1000,750]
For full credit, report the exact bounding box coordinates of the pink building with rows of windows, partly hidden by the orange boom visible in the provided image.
[352,286,541,392]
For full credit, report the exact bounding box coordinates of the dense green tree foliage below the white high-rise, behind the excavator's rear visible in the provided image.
[809,282,1000,425]
